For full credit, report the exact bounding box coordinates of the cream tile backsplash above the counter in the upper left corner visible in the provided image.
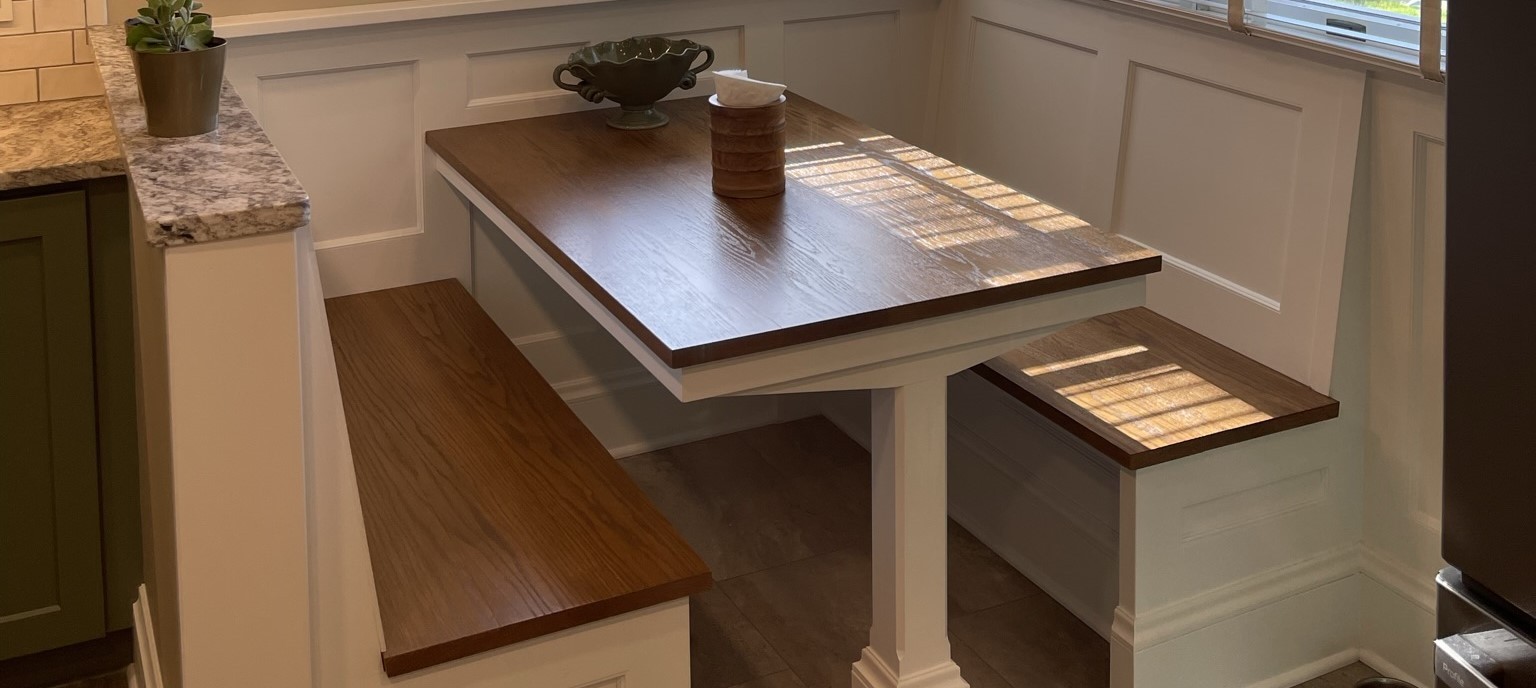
[0,0,106,104]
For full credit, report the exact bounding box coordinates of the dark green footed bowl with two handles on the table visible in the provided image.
[554,35,714,129]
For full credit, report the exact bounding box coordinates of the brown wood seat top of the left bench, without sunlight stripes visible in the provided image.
[326,280,710,676]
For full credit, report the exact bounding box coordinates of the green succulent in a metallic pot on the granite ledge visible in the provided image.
[127,0,224,137]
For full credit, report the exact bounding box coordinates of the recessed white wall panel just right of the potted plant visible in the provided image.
[258,63,419,246]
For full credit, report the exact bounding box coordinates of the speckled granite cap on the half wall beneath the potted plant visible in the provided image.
[91,26,309,246]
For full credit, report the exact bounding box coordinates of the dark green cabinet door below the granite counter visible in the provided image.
[0,192,106,659]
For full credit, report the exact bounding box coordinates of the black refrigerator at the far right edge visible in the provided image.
[1427,0,1536,688]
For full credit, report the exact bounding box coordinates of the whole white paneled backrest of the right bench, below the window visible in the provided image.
[935,0,1366,392]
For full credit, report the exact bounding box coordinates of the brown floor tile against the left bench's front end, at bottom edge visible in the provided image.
[688,587,788,688]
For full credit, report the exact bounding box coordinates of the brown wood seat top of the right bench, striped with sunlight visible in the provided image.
[975,309,1339,470]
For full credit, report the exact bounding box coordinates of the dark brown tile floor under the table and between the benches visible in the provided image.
[621,418,1394,688]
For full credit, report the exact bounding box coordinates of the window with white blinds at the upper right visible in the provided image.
[1118,0,1450,80]
